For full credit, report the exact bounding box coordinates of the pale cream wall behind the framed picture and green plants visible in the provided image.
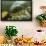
[0,0,46,40]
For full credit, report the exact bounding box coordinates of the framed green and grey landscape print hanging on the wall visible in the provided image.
[1,0,32,21]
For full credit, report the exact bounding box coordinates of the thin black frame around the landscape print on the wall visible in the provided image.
[1,0,32,21]
